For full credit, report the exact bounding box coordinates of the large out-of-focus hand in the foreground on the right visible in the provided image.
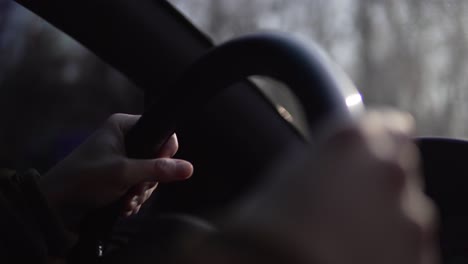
[231,111,438,264]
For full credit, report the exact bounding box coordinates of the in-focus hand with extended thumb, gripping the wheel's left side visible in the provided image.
[39,114,193,233]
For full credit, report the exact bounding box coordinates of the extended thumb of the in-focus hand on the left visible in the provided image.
[124,158,193,185]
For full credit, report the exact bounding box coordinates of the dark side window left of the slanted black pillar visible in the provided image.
[0,0,143,169]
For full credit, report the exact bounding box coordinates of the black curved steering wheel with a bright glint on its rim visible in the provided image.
[75,33,364,260]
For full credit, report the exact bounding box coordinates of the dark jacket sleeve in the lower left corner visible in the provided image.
[0,170,71,263]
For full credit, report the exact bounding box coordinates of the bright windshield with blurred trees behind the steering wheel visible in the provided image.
[171,0,468,137]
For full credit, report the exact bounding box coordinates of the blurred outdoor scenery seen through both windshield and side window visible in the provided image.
[0,0,468,168]
